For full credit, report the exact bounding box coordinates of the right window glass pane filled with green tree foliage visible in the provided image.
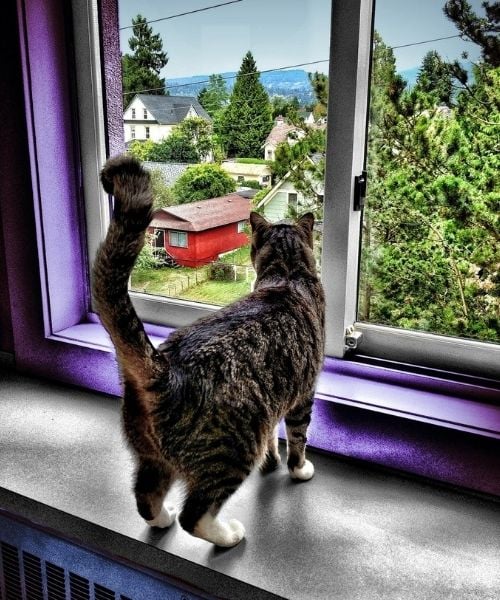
[358,0,500,342]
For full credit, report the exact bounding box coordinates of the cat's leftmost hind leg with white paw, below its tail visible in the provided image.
[134,457,176,528]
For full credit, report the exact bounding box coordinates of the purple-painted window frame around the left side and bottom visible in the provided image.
[0,0,500,496]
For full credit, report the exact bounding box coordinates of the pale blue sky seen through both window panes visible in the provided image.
[119,0,482,81]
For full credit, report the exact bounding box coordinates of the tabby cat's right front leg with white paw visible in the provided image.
[285,396,314,481]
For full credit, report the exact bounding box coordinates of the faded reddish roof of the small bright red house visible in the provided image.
[150,194,250,231]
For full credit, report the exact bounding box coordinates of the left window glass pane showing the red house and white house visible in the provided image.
[119,0,331,305]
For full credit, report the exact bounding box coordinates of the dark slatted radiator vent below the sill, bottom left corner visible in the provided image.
[0,542,132,600]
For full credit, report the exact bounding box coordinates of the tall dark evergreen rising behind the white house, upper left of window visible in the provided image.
[122,14,168,106]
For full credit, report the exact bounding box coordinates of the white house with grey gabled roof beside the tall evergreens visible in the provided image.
[123,94,212,143]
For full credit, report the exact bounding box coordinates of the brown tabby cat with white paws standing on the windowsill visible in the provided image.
[93,155,324,547]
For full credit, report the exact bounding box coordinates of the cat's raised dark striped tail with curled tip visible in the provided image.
[93,156,164,379]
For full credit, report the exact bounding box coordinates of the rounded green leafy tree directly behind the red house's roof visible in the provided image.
[172,164,236,204]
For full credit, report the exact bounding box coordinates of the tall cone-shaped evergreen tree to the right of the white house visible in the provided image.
[221,52,273,157]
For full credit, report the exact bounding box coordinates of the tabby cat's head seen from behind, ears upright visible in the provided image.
[250,212,316,277]
